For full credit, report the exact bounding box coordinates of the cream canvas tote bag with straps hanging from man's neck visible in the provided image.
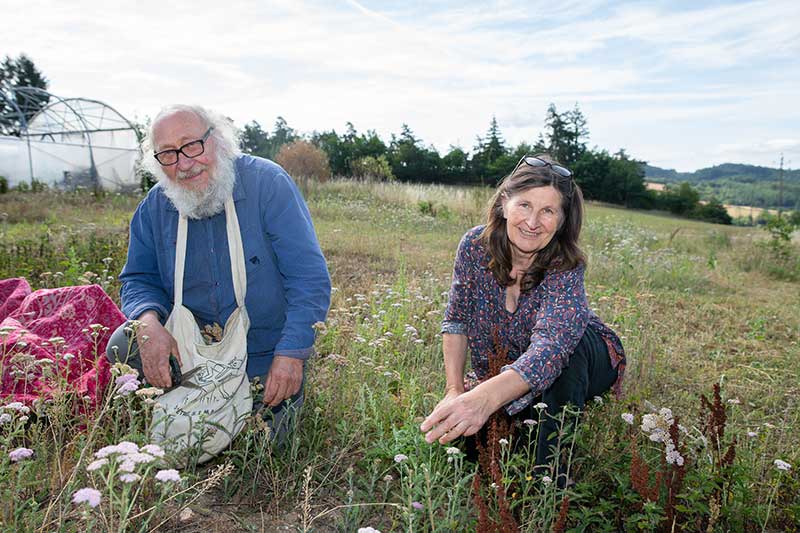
[151,197,253,463]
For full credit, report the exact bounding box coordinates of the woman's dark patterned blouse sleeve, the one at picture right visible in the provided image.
[502,266,590,415]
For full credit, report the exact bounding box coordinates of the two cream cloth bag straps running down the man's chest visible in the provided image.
[174,196,247,307]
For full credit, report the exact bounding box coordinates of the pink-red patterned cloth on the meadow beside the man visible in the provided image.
[0,278,125,405]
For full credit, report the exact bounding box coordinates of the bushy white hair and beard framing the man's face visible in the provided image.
[142,104,241,219]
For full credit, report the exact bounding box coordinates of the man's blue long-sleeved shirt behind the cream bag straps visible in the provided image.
[120,155,331,378]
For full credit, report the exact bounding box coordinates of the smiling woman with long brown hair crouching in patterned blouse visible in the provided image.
[420,155,625,465]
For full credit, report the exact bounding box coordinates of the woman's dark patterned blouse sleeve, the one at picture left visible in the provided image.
[441,232,475,335]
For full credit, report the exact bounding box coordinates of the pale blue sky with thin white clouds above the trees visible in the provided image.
[0,0,800,171]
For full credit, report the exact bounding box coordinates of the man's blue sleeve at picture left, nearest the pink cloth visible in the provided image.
[119,198,172,321]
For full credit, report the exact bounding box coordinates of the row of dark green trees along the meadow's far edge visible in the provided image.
[241,104,731,224]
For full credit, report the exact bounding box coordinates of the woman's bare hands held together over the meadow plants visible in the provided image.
[420,389,495,444]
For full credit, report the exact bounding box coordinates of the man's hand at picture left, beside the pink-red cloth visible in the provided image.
[136,311,181,389]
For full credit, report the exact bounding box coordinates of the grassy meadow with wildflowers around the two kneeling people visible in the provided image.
[0,180,800,533]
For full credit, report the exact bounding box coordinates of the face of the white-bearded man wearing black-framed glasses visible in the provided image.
[153,111,217,191]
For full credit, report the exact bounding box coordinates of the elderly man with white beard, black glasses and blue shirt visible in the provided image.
[109,105,331,432]
